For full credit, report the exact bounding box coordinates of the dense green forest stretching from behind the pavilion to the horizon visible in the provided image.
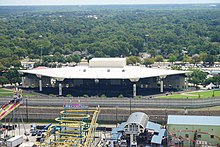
[0,5,220,68]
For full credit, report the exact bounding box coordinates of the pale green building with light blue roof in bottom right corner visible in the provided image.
[167,115,220,147]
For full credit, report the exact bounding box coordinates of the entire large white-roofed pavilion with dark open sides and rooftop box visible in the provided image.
[19,58,189,97]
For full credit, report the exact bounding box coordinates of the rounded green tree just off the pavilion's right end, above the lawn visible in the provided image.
[189,69,207,86]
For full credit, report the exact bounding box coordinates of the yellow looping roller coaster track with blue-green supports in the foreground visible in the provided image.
[35,108,100,147]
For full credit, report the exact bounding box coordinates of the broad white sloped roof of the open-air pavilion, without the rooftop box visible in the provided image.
[19,66,187,79]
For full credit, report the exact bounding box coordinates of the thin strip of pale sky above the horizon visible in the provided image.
[0,0,220,5]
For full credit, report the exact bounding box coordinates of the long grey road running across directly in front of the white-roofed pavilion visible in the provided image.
[0,97,220,108]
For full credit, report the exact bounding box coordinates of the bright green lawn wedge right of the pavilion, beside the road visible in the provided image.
[159,90,220,98]
